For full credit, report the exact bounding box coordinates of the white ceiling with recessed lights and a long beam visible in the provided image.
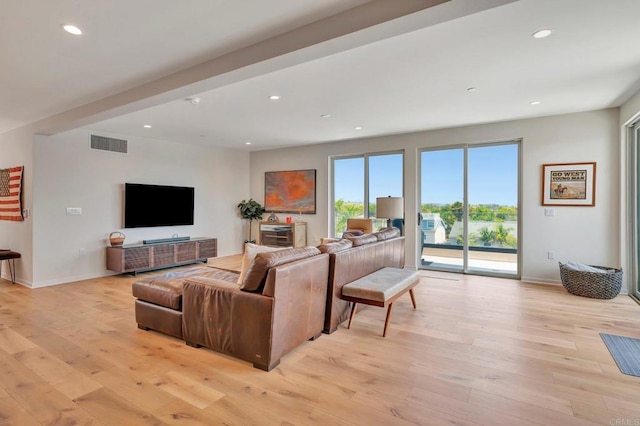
[0,0,640,150]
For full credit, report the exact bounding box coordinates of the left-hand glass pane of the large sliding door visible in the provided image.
[420,148,464,270]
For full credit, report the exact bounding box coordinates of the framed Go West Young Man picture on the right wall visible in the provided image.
[542,163,596,207]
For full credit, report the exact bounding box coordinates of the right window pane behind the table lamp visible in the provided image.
[369,154,403,230]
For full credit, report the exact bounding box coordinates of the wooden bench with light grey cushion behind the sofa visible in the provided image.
[342,267,420,337]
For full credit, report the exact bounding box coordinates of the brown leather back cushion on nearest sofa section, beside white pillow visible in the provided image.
[240,246,320,293]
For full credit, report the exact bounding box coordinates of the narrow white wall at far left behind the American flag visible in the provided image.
[0,127,33,286]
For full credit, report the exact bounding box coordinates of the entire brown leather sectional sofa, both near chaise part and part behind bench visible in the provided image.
[133,230,404,371]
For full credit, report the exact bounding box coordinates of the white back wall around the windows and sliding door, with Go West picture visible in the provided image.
[251,108,620,283]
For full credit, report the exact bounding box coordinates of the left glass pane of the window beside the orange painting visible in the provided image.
[333,157,364,236]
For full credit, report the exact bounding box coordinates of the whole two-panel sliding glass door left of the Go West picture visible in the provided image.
[419,142,520,277]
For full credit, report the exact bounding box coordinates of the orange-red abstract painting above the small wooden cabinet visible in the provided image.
[264,169,316,214]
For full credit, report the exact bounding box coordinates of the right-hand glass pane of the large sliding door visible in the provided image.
[467,144,518,274]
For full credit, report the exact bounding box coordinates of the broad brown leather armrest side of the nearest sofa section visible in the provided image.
[182,278,274,370]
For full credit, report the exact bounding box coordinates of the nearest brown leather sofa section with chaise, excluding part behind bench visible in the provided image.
[133,247,329,371]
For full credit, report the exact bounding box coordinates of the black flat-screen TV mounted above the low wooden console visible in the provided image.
[124,183,195,228]
